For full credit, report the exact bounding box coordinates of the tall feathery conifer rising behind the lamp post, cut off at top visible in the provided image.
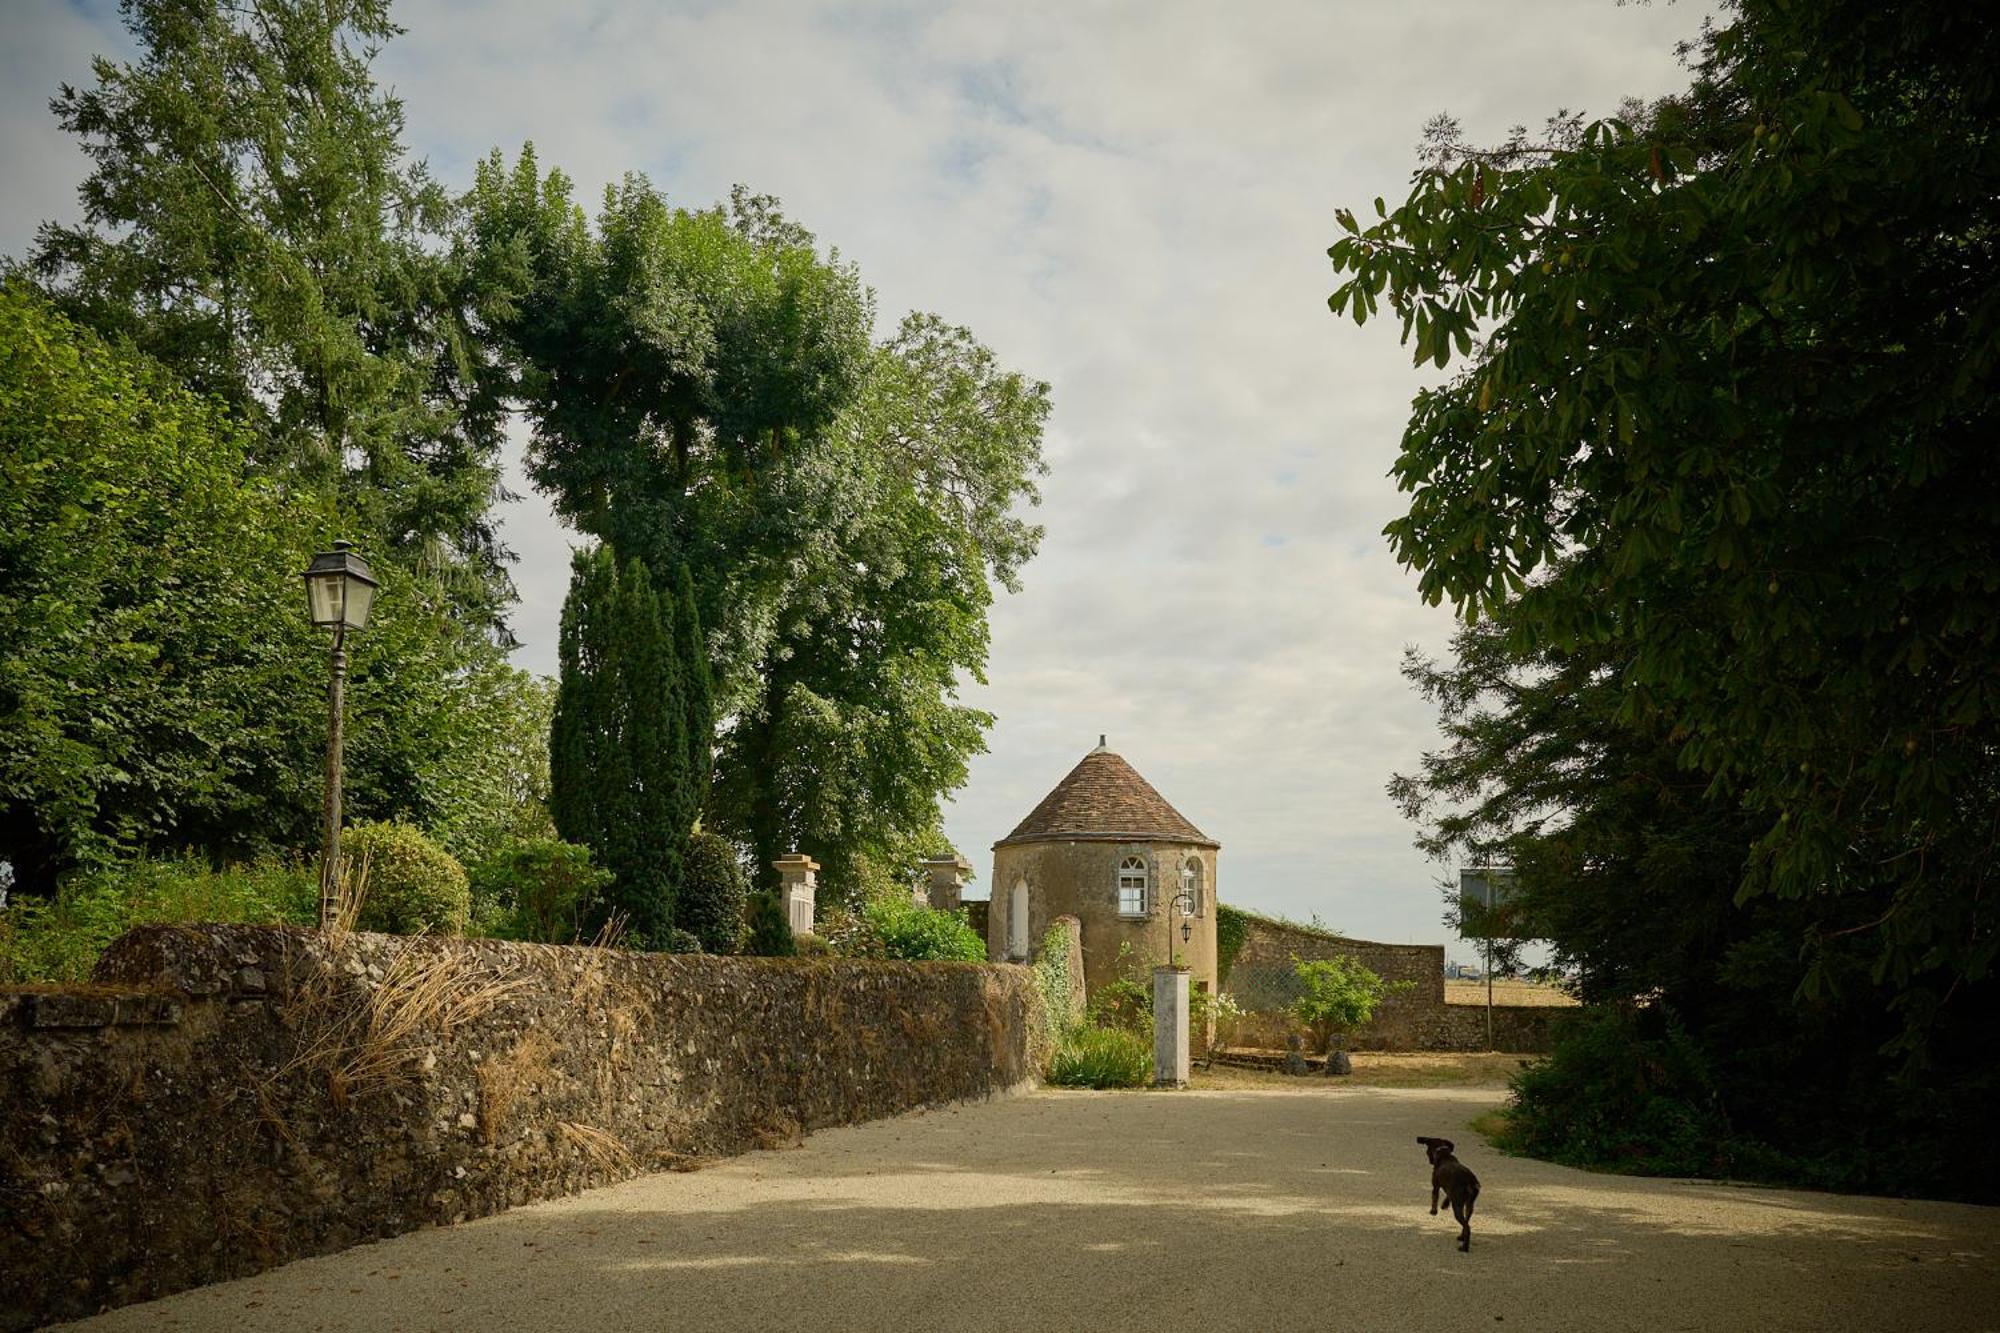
[28,0,512,630]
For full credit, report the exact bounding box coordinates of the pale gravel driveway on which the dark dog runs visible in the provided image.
[62,1087,2000,1333]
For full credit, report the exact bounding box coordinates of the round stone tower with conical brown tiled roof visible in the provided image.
[986,737,1222,991]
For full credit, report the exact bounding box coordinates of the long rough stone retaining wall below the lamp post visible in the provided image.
[0,927,1042,1329]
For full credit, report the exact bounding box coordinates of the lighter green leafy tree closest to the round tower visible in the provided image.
[712,314,1048,899]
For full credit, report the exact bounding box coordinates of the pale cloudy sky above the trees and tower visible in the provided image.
[0,0,1704,944]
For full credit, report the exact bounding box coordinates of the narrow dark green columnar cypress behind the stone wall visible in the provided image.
[548,546,712,945]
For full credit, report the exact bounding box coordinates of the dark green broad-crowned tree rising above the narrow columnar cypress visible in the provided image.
[466,146,872,676]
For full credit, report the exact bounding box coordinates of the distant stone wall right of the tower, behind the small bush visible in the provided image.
[1222,913,1568,1053]
